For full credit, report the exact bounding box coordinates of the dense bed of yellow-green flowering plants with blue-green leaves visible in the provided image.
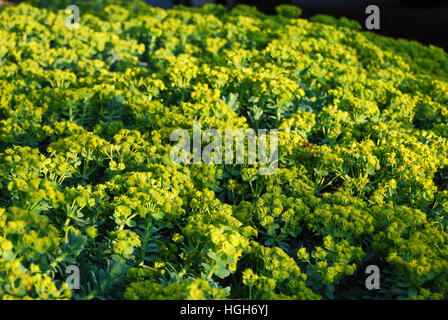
[0,1,448,299]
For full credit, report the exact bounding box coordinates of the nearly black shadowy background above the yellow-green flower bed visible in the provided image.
[159,0,448,52]
